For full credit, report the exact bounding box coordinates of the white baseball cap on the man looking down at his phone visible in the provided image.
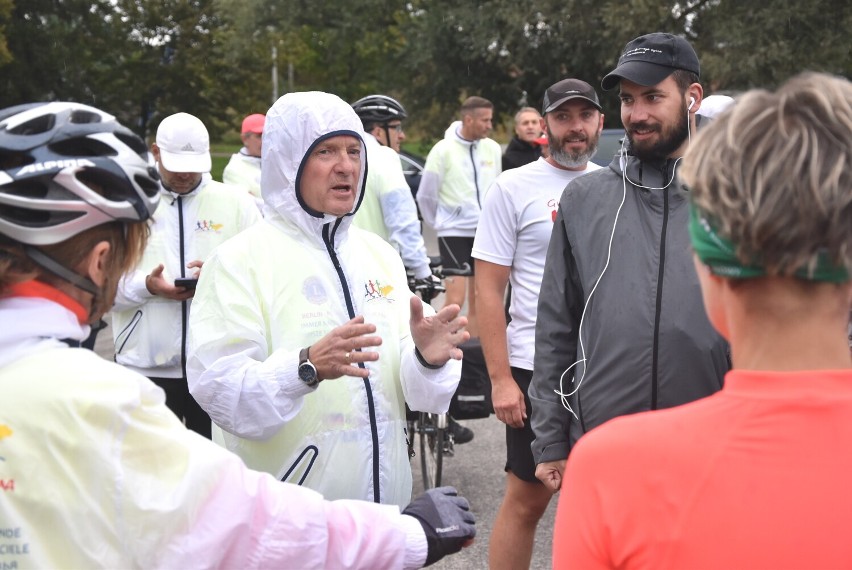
[157,113,211,172]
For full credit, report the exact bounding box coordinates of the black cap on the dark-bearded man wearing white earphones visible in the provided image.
[601,32,701,91]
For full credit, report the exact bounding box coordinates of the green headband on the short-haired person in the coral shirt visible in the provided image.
[689,203,849,283]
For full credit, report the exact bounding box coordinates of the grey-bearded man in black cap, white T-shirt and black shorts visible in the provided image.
[472,79,604,570]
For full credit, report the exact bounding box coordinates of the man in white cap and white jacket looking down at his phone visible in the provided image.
[112,113,260,438]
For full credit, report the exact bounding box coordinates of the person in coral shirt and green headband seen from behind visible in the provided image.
[553,73,852,569]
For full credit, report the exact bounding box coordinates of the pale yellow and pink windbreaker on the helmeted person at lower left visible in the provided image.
[0,297,427,570]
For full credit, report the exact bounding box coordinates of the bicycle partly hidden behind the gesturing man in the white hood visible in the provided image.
[406,256,471,490]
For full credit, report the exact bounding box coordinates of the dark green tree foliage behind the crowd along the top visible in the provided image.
[0,0,852,138]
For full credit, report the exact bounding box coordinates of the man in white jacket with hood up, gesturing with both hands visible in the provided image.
[187,92,469,506]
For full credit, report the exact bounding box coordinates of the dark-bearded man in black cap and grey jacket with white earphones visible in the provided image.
[529,33,729,492]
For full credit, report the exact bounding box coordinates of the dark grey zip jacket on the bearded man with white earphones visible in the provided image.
[529,144,729,463]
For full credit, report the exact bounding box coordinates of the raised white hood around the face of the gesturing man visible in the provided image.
[260,91,367,236]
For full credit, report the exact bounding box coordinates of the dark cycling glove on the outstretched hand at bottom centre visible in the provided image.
[402,487,476,566]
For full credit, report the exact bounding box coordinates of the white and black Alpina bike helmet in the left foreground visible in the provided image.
[0,102,160,246]
